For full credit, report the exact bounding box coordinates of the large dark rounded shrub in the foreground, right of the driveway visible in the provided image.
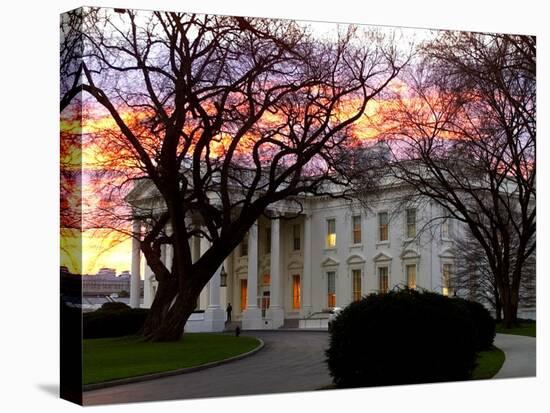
[326,289,476,387]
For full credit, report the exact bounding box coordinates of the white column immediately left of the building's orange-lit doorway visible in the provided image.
[243,222,263,330]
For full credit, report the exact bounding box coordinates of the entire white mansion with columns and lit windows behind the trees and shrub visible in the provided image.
[131,179,466,331]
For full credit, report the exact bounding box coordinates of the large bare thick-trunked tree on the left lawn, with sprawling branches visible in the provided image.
[62,9,408,341]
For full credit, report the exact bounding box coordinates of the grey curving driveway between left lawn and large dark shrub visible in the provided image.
[84,331,331,405]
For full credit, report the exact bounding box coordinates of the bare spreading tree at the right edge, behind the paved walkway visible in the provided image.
[386,32,536,327]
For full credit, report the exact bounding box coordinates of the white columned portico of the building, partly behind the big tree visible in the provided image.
[130,215,311,331]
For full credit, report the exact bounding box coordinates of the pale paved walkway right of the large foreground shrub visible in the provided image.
[494,334,537,379]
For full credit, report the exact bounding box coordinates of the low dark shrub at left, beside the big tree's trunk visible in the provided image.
[82,303,149,338]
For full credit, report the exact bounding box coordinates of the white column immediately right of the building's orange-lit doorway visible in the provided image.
[266,219,285,328]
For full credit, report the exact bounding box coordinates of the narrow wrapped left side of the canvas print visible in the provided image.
[60,9,83,404]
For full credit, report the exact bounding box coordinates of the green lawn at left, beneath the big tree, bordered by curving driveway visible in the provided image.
[83,333,260,384]
